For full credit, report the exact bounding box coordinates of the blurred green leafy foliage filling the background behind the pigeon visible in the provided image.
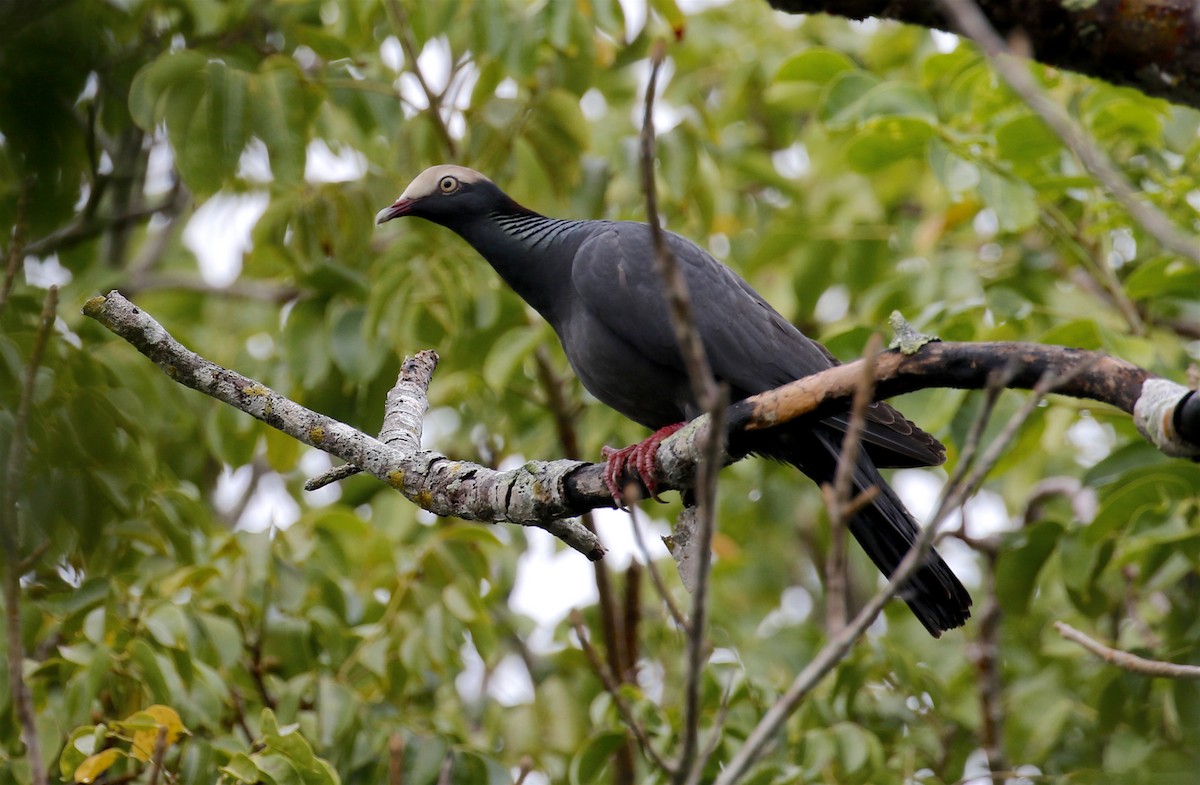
[0,0,1200,785]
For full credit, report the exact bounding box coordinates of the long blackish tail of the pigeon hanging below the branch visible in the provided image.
[766,426,971,637]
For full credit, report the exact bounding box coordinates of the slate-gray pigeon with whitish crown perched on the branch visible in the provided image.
[378,167,971,635]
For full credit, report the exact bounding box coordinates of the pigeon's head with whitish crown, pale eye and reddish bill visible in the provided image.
[376,164,528,228]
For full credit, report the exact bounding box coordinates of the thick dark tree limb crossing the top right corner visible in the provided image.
[768,0,1200,108]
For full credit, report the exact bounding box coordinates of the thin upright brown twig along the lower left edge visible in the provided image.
[0,286,59,785]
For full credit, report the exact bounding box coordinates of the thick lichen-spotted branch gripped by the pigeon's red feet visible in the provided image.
[84,292,1200,558]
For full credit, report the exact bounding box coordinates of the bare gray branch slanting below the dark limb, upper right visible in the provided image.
[938,0,1200,263]
